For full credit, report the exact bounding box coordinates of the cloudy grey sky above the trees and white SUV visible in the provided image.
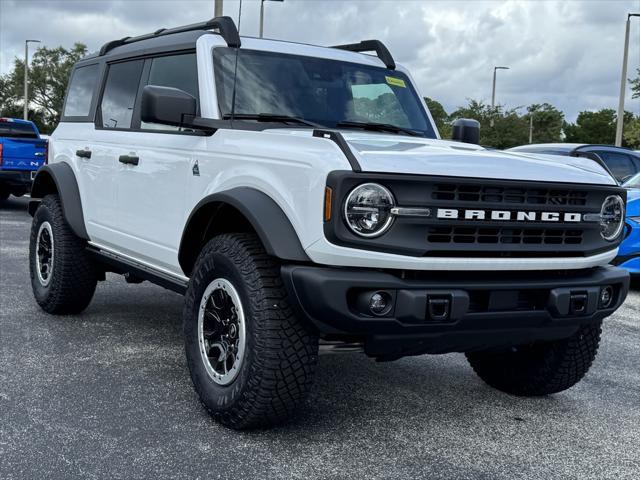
[0,0,640,120]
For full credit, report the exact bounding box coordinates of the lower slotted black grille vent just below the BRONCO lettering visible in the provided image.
[427,226,583,245]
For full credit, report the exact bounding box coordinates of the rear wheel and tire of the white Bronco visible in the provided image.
[29,195,98,315]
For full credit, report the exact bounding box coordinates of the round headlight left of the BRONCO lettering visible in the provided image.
[344,183,395,237]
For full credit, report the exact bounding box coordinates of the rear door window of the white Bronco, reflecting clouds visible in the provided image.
[100,60,144,128]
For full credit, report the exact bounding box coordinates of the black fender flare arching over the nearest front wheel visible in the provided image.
[178,187,311,275]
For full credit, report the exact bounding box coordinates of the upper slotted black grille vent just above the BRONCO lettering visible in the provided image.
[431,183,588,206]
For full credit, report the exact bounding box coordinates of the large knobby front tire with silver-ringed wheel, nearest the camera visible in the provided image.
[184,234,318,429]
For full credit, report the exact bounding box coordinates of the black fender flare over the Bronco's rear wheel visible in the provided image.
[29,162,89,240]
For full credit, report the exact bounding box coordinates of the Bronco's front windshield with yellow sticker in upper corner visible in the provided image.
[214,48,436,138]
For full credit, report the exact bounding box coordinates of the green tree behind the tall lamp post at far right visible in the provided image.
[564,108,633,145]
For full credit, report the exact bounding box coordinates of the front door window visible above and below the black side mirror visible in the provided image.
[141,53,199,130]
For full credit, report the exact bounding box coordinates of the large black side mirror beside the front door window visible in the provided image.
[140,85,198,127]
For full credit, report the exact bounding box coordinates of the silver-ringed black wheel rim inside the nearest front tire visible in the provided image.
[198,278,246,385]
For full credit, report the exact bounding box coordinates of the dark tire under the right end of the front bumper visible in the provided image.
[467,322,602,396]
